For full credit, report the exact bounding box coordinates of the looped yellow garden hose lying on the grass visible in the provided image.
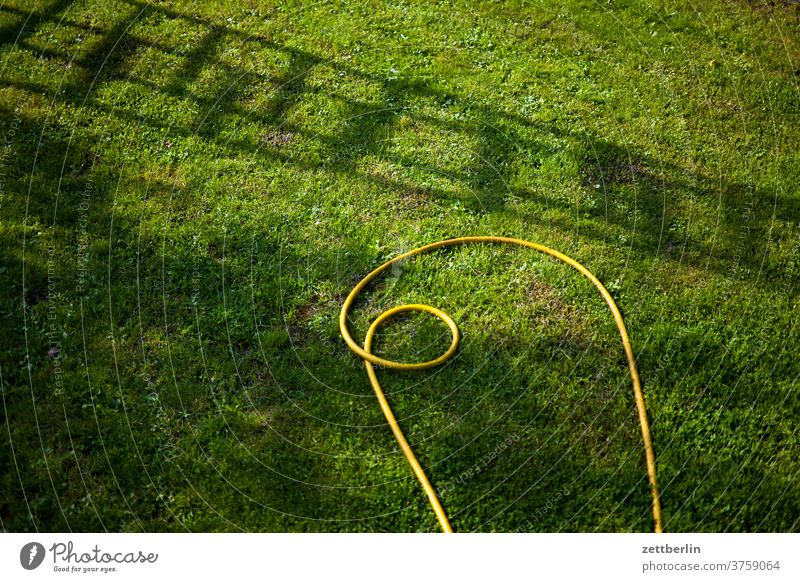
[339,236,662,533]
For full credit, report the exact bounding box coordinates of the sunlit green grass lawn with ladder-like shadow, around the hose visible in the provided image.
[0,0,800,531]
